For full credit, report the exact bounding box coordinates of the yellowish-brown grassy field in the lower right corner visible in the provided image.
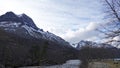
[88,60,120,68]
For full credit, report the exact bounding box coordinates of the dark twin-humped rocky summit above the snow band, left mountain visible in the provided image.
[0,11,38,29]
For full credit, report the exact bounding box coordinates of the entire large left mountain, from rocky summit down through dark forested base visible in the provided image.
[0,12,77,66]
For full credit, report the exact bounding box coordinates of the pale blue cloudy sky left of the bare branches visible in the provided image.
[0,0,103,43]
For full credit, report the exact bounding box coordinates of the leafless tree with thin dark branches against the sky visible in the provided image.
[99,0,120,46]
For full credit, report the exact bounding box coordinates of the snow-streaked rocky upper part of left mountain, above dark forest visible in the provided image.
[0,12,69,45]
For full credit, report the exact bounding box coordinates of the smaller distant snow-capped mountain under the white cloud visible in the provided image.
[76,40,113,49]
